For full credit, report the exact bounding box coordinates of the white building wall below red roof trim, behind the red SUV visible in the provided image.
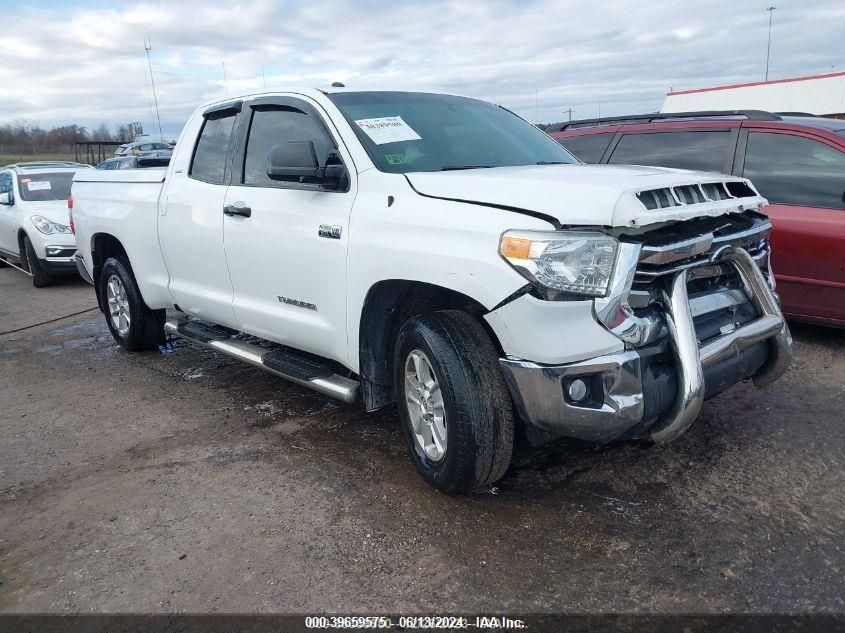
[660,72,845,114]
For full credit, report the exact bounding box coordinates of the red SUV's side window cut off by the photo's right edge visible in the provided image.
[742,131,845,209]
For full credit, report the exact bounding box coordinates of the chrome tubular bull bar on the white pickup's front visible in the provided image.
[650,246,792,444]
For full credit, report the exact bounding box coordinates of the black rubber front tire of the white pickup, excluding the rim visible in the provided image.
[393,310,514,494]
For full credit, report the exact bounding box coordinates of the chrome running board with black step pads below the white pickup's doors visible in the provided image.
[164,319,358,403]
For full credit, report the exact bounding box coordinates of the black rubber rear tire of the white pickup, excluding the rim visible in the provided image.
[99,257,164,352]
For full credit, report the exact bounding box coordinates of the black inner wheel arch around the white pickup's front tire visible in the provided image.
[358,279,501,411]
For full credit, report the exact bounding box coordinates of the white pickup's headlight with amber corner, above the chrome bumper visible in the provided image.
[499,231,617,297]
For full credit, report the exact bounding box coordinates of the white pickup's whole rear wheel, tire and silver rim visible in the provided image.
[99,257,164,351]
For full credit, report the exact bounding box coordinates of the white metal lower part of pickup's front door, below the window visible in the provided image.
[225,186,352,362]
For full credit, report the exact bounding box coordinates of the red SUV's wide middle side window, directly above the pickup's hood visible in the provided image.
[608,130,733,172]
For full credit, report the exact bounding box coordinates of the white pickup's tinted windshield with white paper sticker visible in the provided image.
[329,92,578,174]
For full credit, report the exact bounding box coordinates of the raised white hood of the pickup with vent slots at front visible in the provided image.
[406,165,766,227]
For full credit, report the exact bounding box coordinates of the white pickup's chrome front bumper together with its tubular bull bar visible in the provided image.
[500,246,792,443]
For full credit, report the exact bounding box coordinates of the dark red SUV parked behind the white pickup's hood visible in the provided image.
[547,110,845,326]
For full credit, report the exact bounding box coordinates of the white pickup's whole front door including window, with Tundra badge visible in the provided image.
[224,98,355,363]
